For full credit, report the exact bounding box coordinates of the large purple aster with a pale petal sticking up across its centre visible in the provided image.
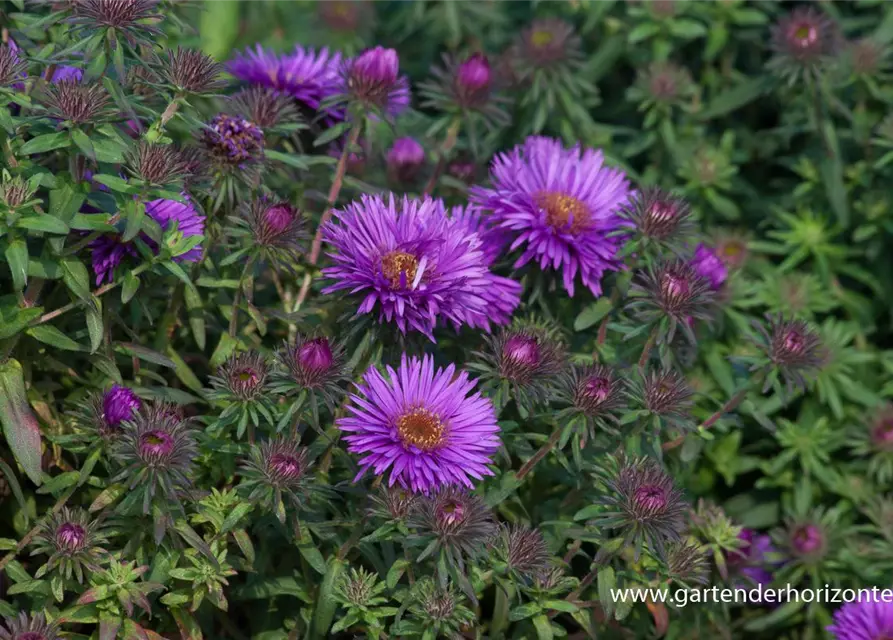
[323,194,488,341]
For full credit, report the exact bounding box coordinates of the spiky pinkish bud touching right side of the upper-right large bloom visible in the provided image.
[623,187,695,247]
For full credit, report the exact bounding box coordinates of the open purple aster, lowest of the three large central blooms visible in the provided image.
[337,354,500,493]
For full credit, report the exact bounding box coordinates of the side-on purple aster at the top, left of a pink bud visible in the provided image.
[227,45,341,109]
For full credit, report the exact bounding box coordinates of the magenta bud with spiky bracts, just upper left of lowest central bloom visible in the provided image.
[276,335,345,403]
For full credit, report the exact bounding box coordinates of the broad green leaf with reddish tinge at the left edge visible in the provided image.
[0,359,41,486]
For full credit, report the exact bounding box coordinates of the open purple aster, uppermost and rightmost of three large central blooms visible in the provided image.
[471,137,631,296]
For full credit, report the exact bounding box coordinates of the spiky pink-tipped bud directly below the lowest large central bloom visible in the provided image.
[409,486,498,568]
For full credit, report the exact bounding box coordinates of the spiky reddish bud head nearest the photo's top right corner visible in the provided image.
[769,6,839,82]
